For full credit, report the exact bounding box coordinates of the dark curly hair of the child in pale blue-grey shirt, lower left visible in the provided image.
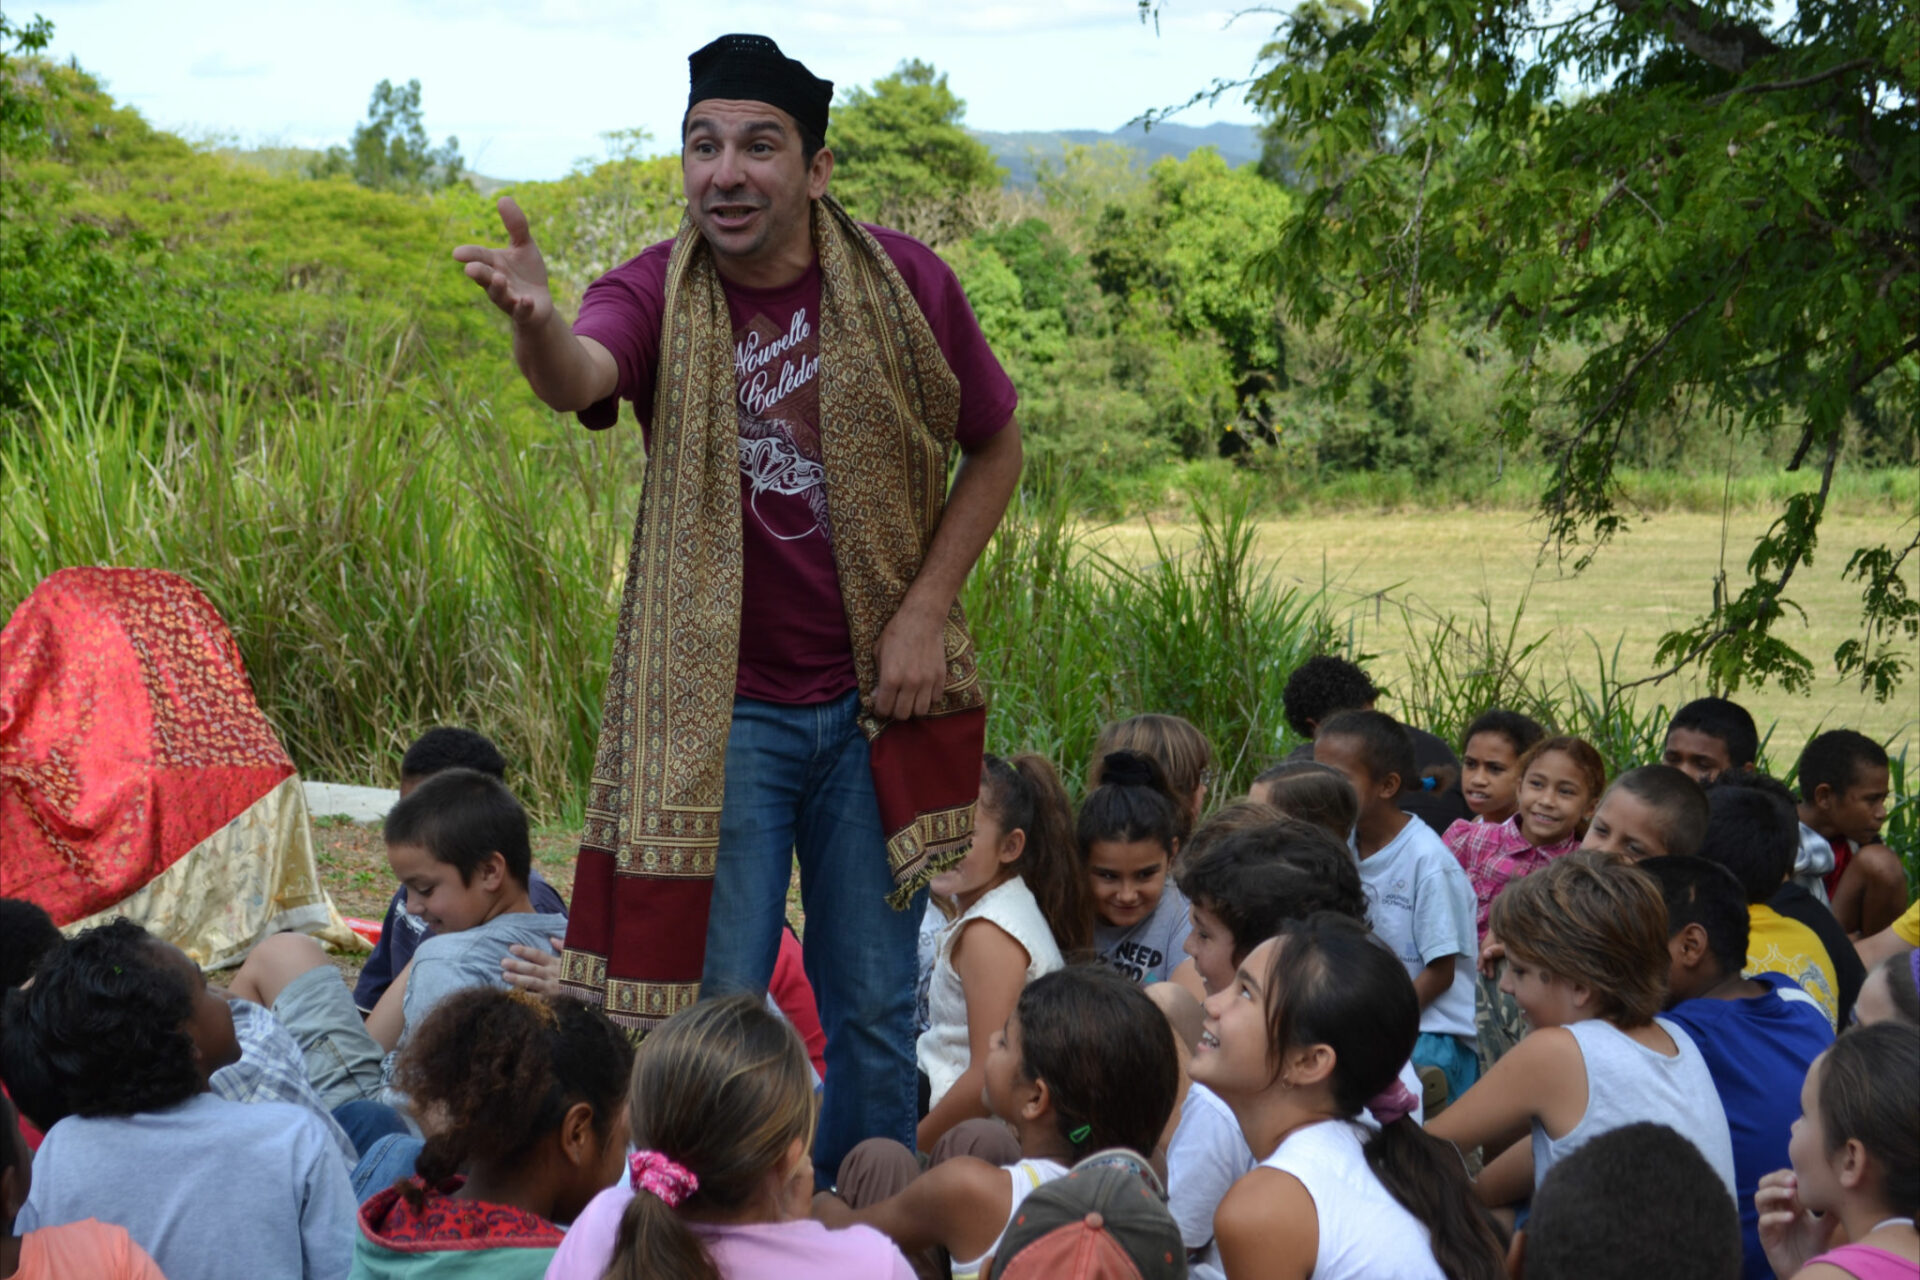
[0,919,205,1128]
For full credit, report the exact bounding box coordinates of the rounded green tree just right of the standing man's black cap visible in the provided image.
[828,59,1002,223]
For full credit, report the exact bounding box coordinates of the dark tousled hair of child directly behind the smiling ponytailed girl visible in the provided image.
[1179,818,1367,963]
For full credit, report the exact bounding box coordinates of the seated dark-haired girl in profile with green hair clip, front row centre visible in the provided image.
[817,965,1179,1280]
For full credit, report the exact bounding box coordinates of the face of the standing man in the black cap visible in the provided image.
[680,98,833,276]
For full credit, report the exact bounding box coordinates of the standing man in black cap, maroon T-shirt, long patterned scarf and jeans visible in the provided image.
[453,35,1021,1180]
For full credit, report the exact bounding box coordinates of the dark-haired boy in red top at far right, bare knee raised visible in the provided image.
[1793,729,1908,936]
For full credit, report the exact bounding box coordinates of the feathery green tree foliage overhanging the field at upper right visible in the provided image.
[1140,0,1920,699]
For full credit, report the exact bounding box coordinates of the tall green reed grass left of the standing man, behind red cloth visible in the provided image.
[0,335,641,816]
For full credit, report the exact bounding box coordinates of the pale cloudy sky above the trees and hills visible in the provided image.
[30,0,1273,178]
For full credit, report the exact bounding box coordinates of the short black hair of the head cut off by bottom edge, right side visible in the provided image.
[1523,1121,1741,1280]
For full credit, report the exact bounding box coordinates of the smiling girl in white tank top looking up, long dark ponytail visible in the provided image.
[1190,912,1505,1280]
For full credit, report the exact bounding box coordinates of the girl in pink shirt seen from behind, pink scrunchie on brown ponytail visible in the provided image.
[547,996,914,1280]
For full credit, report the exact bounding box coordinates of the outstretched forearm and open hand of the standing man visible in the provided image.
[453,196,620,413]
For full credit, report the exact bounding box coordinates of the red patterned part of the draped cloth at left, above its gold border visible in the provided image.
[0,568,294,925]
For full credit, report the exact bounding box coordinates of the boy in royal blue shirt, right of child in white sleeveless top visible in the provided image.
[1638,858,1834,1280]
